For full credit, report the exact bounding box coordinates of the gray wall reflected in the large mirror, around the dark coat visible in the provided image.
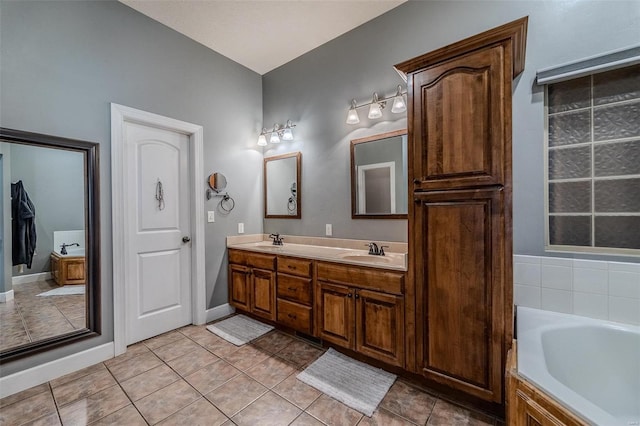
[9,144,85,277]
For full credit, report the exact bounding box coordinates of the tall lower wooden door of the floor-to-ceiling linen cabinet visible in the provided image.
[411,188,511,402]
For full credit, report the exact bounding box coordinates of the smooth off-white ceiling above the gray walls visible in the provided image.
[120,0,407,74]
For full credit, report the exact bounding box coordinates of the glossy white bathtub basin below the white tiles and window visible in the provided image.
[517,307,640,426]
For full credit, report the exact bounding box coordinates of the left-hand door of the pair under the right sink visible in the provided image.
[317,281,354,349]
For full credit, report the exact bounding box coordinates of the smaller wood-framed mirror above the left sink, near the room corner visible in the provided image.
[264,152,302,219]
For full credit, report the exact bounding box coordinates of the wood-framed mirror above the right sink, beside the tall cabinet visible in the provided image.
[351,129,408,219]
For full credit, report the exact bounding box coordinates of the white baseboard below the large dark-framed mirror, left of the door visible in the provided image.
[0,342,114,398]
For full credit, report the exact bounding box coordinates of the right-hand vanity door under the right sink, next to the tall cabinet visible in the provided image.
[354,290,404,367]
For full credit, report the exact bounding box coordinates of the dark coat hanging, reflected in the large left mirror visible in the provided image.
[11,180,36,268]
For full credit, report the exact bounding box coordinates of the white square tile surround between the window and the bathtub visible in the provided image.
[513,255,640,325]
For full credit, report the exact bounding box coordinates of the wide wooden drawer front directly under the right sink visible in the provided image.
[316,262,404,294]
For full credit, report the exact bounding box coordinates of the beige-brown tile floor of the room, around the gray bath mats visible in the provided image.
[0,320,502,426]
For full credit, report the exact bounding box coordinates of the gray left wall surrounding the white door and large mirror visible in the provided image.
[0,0,262,376]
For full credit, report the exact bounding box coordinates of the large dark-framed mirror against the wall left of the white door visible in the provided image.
[0,128,100,363]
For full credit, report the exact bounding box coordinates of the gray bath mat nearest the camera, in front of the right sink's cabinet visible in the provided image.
[297,349,396,416]
